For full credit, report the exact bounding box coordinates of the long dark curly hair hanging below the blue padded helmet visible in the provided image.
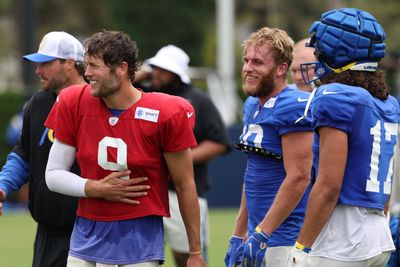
[320,70,390,100]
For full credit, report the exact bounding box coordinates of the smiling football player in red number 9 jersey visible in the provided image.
[46,31,206,267]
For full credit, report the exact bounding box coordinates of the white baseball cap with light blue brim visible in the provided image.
[23,31,84,62]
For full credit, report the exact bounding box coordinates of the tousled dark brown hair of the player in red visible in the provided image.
[85,31,139,81]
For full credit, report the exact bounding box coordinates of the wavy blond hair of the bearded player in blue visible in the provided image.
[242,27,294,69]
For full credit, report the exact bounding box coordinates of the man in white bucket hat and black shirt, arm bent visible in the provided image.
[136,45,230,267]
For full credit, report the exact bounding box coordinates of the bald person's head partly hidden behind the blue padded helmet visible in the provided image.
[289,39,316,92]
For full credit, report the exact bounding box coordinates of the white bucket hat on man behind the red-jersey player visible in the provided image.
[145,45,190,83]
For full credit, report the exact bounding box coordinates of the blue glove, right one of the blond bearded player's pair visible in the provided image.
[242,226,269,267]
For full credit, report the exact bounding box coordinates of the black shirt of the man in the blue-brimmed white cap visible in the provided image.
[13,90,79,233]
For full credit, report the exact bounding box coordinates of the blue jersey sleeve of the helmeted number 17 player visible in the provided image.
[312,84,355,133]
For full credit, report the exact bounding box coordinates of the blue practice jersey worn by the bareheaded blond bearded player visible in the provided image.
[240,87,312,247]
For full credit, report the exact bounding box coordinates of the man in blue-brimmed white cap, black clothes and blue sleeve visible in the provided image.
[0,31,147,267]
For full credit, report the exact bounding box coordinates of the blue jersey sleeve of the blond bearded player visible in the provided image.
[274,90,312,136]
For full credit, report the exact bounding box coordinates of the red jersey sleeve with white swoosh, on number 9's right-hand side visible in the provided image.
[161,97,197,152]
